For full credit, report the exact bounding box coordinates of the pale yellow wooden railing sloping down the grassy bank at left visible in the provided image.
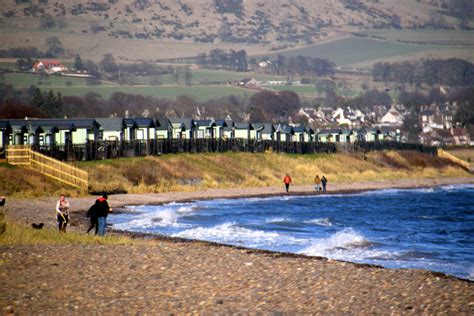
[7,145,89,189]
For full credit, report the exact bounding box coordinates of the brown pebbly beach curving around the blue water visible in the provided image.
[0,178,474,315]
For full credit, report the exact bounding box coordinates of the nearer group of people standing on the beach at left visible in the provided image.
[56,193,112,236]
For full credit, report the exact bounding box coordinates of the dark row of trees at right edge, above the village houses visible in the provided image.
[372,58,474,87]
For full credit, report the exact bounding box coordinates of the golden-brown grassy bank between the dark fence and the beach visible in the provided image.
[0,151,470,197]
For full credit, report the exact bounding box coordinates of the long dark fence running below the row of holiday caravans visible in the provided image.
[3,139,437,162]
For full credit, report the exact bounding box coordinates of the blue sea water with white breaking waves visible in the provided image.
[110,185,474,280]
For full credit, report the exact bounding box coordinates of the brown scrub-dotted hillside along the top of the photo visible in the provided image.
[0,0,466,47]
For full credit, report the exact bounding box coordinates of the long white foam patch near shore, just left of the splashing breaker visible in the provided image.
[172,222,302,247]
